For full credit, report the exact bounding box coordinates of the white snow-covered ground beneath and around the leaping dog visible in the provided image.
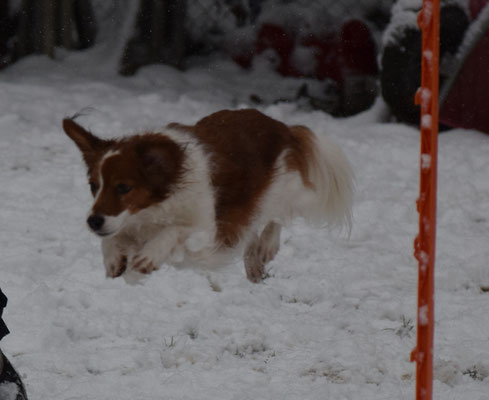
[0,50,489,400]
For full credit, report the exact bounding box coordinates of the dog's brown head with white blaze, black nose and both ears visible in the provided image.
[63,119,184,236]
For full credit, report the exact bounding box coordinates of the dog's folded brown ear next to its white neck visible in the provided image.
[137,136,184,197]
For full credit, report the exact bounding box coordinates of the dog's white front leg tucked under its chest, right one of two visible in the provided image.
[128,228,186,274]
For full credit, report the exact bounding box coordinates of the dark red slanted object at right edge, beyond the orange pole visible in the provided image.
[440,0,489,133]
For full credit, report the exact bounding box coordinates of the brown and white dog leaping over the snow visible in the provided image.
[63,109,354,283]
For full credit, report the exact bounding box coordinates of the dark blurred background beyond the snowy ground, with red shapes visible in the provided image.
[0,0,489,132]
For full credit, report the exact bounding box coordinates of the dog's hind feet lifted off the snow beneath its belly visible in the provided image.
[244,222,281,283]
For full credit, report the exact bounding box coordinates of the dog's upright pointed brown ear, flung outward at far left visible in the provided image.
[63,118,109,170]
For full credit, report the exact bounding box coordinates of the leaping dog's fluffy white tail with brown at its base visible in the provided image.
[291,126,354,232]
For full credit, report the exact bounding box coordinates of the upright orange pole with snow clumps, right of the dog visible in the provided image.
[411,0,440,400]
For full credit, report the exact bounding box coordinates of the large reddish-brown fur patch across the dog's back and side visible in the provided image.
[187,110,308,246]
